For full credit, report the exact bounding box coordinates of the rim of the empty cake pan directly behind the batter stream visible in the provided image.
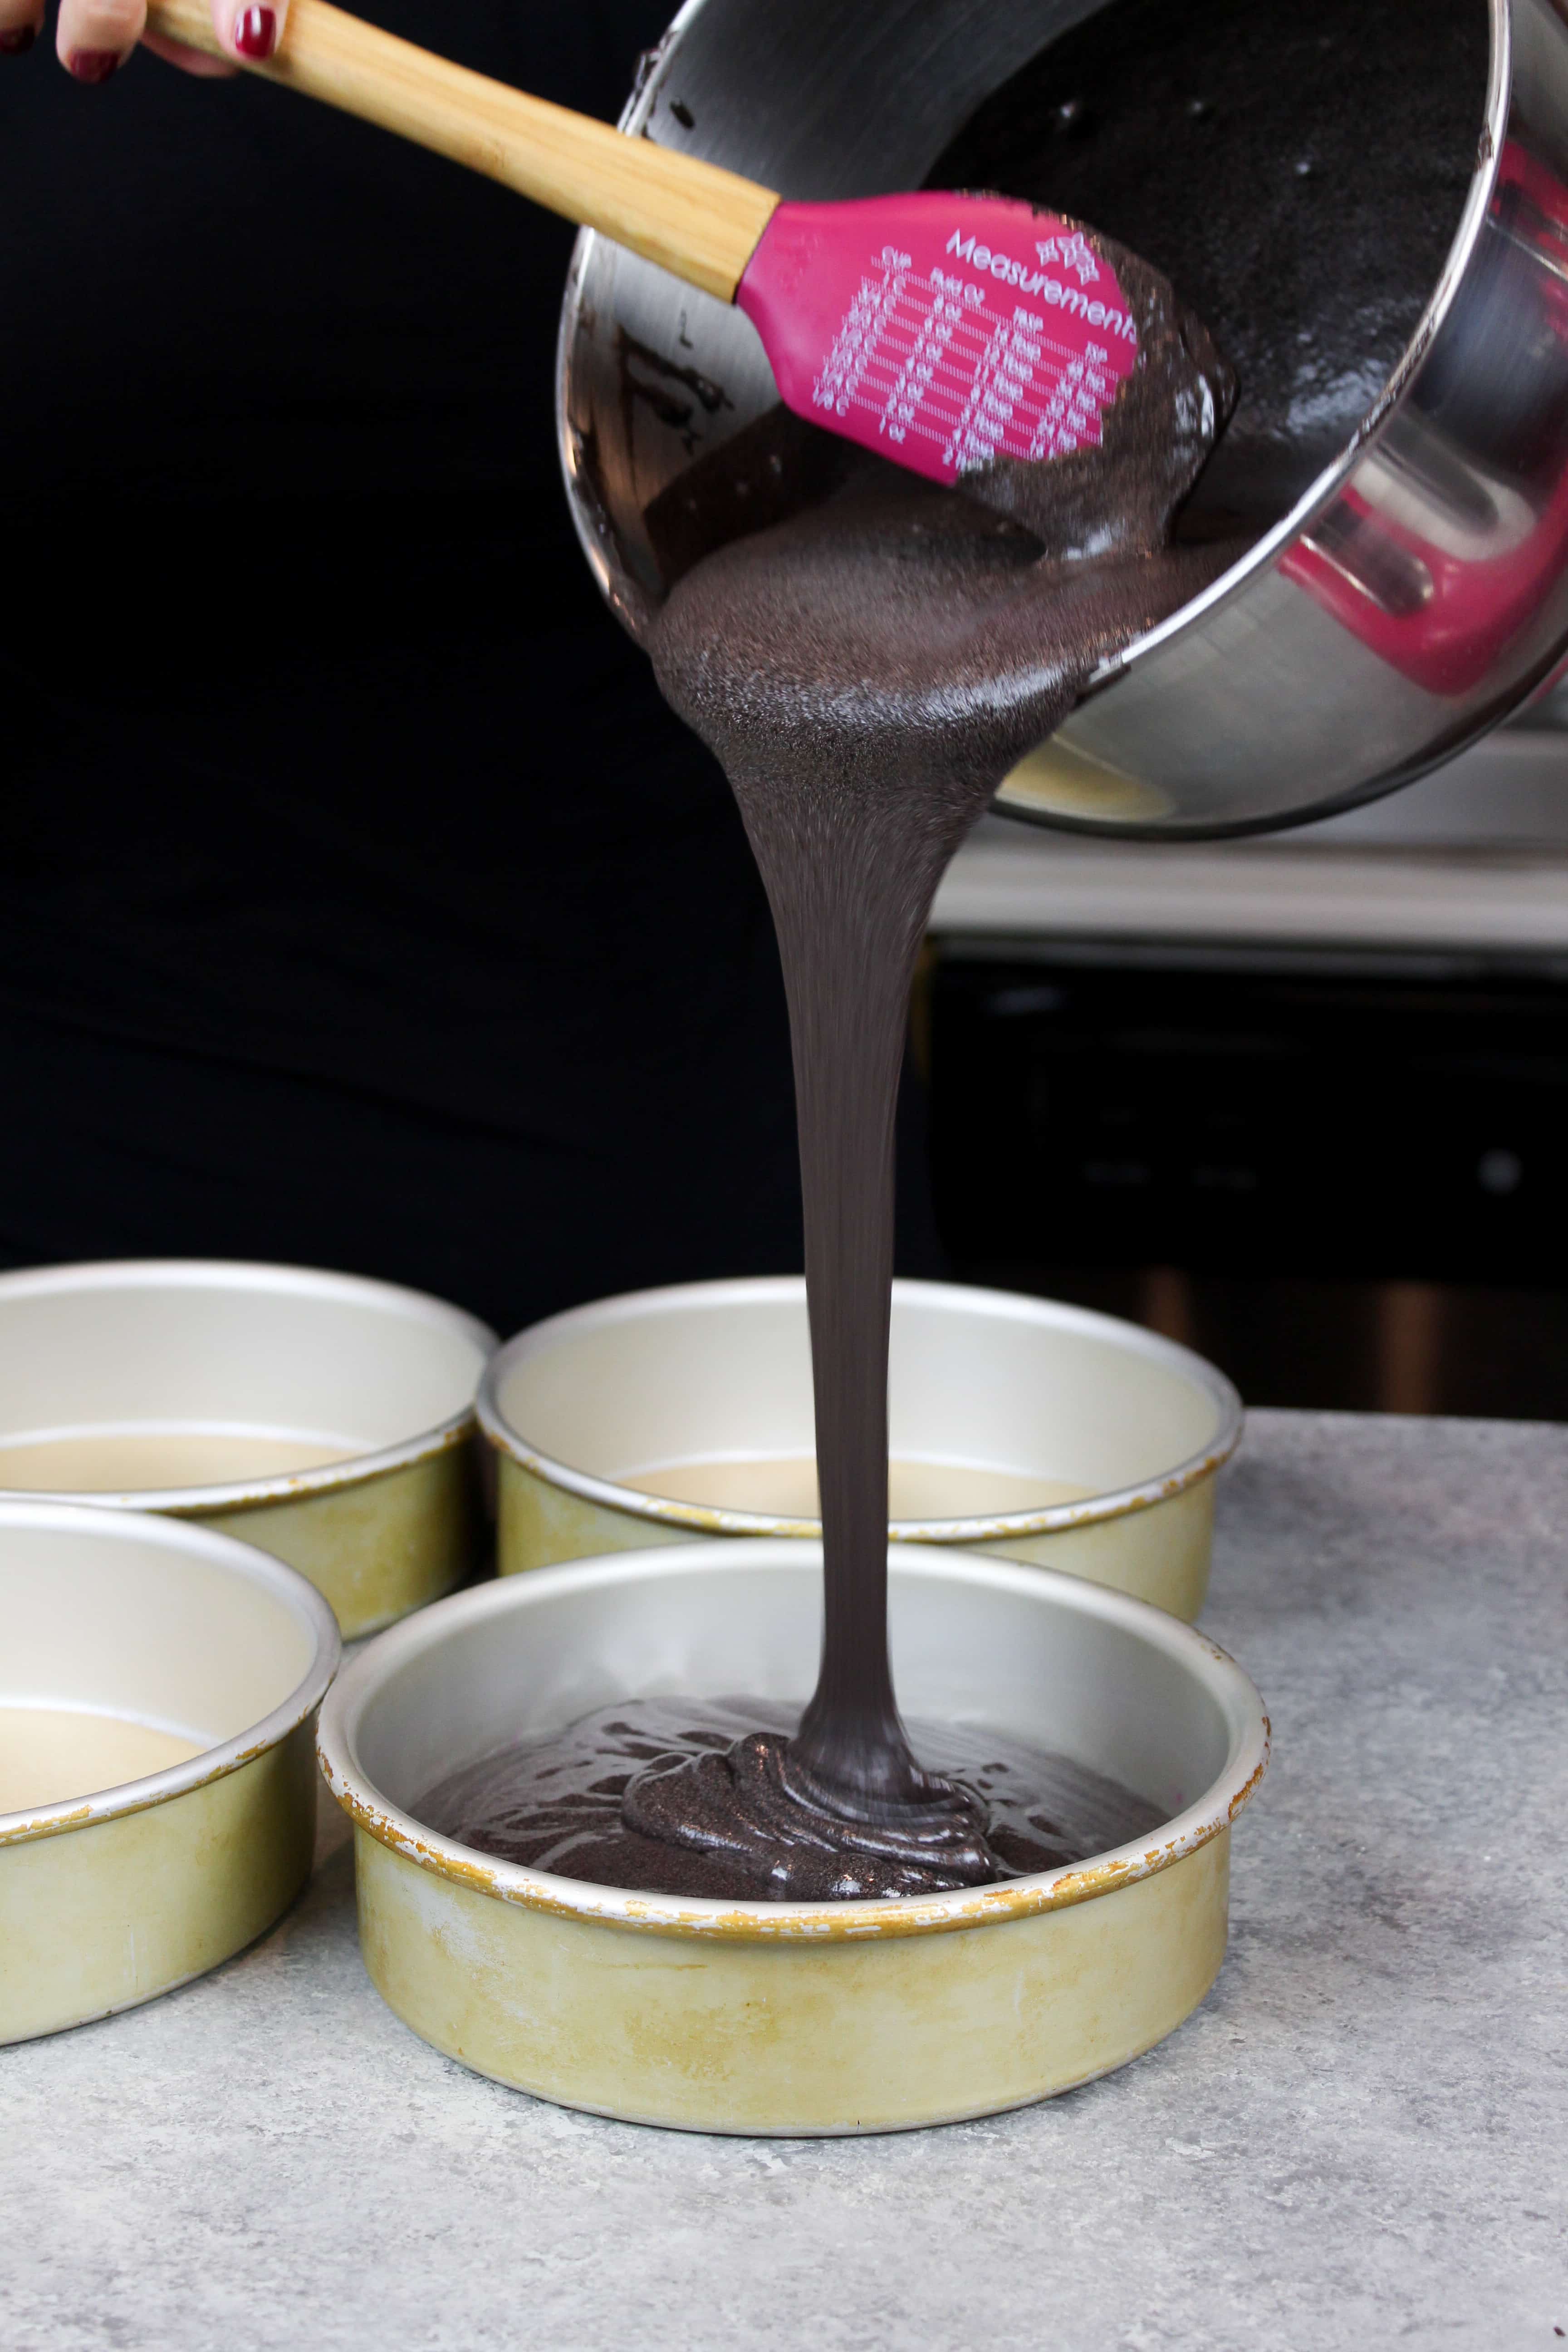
[475,1275,1246,1545]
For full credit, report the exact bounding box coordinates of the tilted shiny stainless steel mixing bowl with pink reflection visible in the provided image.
[559,0,1568,838]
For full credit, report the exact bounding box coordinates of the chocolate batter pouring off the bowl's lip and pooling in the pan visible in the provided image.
[423,223,1232,1901]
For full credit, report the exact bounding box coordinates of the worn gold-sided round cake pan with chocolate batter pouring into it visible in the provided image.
[317,1541,1267,2136]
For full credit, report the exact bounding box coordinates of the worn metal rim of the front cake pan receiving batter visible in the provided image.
[315,1536,1269,1945]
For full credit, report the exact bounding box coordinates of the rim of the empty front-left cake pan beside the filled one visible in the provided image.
[0,1496,343,1849]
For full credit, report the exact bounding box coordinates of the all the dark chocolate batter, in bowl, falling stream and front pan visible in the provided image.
[423,0,1486,1901]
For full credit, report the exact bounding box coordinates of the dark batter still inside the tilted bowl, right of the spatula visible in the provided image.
[926,0,1488,529]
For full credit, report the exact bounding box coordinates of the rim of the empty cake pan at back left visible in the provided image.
[0,1258,501,1519]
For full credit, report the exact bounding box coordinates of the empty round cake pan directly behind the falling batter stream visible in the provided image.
[480,1275,1241,1618]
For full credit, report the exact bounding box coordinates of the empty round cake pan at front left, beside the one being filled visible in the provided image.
[0,1500,338,2042]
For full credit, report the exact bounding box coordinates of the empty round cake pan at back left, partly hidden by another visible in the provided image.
[0,1258,496,1637]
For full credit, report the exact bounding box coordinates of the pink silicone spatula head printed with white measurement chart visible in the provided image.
[736,191,1138,485]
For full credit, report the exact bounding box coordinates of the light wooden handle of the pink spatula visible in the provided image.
[148,0,778,301]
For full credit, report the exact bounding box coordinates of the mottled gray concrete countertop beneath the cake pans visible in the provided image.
[0,1414,1568,2352]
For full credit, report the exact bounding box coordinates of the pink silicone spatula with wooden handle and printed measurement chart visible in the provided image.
[148,0,1138,482]
